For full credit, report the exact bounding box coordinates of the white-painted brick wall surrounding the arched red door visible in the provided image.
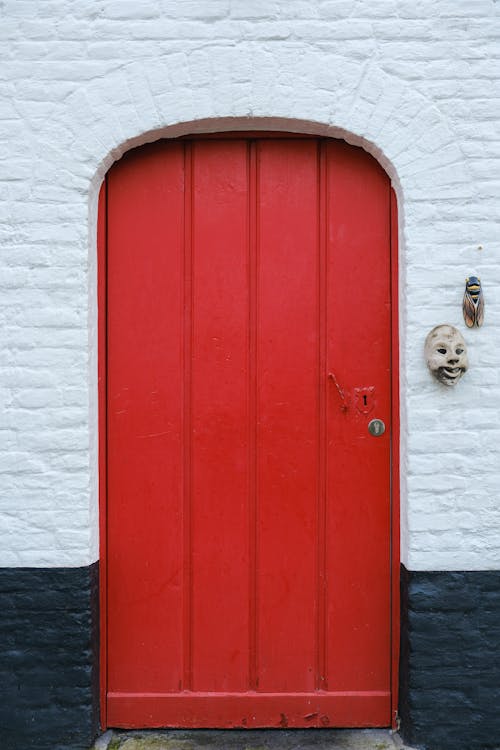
[0,0,500,570]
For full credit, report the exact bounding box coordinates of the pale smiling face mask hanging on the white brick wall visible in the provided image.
[425,325,469,385]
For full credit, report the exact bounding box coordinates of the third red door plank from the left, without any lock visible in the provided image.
[257,140,318,692]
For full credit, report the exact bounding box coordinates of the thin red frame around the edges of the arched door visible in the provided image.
[97,131,401,730]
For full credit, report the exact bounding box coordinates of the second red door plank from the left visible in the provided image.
[191,141,249,691]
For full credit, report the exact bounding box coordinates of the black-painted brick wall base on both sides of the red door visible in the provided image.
[0,563,500,750]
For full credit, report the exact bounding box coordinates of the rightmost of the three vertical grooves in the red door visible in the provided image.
[316,141,328,690]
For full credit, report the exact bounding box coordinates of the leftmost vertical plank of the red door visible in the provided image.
[107,144,184,692]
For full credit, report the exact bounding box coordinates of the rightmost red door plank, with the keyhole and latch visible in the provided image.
[326,144,391,690]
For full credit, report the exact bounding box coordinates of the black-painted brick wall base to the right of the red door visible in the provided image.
[400,567,500,750]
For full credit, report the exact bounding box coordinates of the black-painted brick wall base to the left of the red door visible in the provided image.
[0,563,99,750]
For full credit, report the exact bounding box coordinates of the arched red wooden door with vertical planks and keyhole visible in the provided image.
[105,136,398,727]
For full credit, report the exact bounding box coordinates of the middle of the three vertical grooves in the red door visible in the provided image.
[247,141,259,690]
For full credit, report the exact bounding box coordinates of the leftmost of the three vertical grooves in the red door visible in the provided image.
[183,143,193,690]
